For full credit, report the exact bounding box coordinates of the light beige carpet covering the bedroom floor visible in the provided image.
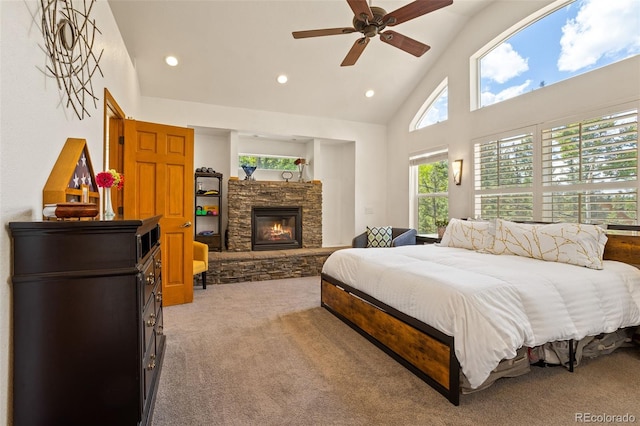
[153,277,640,426]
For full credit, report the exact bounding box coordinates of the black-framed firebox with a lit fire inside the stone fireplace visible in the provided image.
[251,207,302,250]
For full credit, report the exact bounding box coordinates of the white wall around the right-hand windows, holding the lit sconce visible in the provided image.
[387,0,640,223]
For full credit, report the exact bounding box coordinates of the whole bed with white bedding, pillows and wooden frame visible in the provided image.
[321,220,640,405]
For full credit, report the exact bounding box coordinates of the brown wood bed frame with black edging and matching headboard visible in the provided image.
[321,225,640,405]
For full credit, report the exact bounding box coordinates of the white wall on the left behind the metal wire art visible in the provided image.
[0,0,139,424]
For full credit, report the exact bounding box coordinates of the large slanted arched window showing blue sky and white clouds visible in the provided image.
[472,0,640,108]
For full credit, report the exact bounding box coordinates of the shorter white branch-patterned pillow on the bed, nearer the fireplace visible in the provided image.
[440,218,493,251]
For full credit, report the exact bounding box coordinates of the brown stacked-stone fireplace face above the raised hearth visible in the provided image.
[227,180,322,252]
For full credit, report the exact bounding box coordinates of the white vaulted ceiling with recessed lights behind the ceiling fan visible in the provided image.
[109,0,493,124]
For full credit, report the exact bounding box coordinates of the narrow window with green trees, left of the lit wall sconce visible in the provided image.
[415,160,449,234]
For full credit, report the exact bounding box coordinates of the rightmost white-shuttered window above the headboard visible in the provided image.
[541,109,638,224]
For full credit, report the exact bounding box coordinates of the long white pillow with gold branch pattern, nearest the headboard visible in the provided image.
[490,219,607,269]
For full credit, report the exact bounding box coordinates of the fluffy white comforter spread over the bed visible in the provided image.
[323,245,640,388]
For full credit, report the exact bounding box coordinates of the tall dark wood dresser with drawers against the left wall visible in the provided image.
[9,216,165,426]
